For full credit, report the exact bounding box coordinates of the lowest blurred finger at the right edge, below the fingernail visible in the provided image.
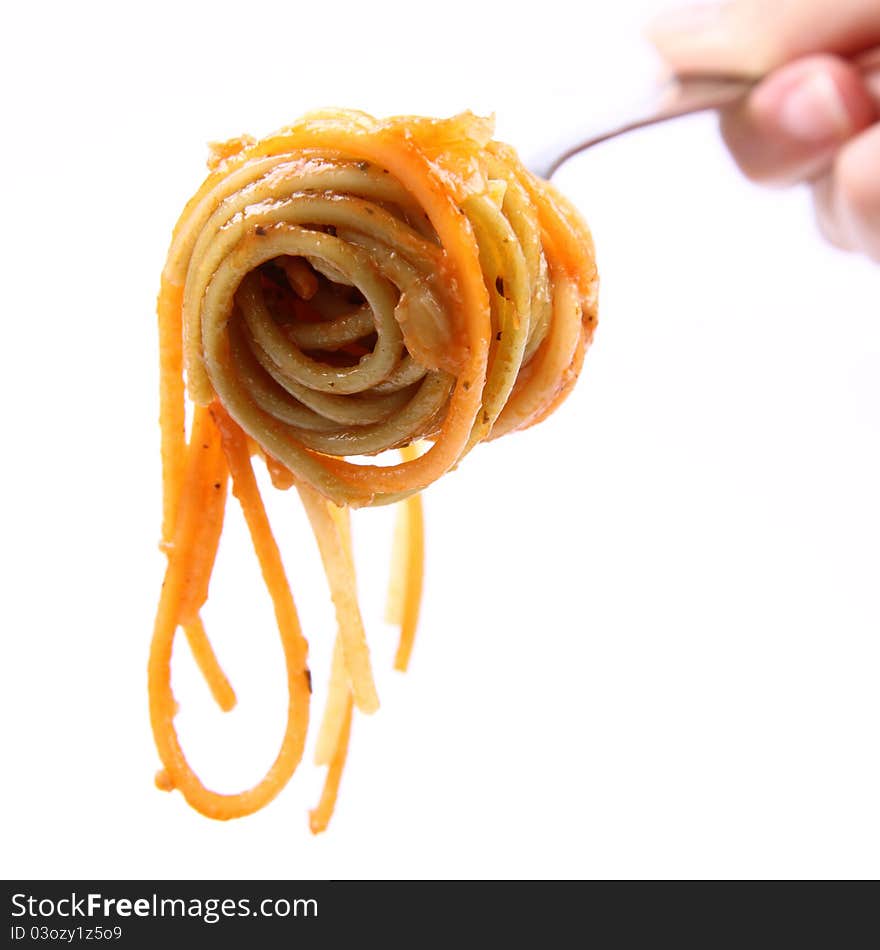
[814,125,880,261]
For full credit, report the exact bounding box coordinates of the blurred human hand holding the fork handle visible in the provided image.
[649,0,880,261]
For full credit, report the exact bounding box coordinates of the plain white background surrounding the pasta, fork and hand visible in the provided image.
[0,0,880,878]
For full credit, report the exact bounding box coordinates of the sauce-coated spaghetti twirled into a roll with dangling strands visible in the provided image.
[149,111,597,831]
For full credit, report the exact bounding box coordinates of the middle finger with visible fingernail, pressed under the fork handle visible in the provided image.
[721,56,878,185]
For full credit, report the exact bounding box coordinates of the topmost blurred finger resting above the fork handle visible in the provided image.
[648,0,880,76]
